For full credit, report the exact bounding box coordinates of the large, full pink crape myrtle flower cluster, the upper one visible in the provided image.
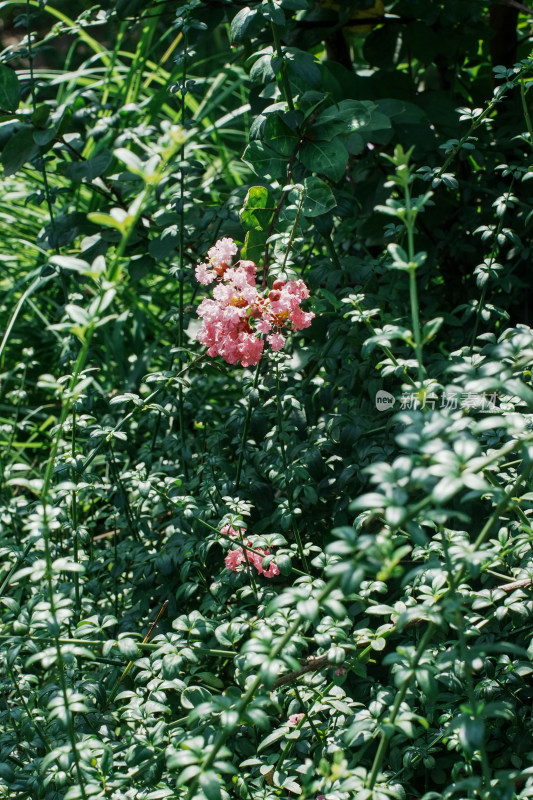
[195,238,315,367]
